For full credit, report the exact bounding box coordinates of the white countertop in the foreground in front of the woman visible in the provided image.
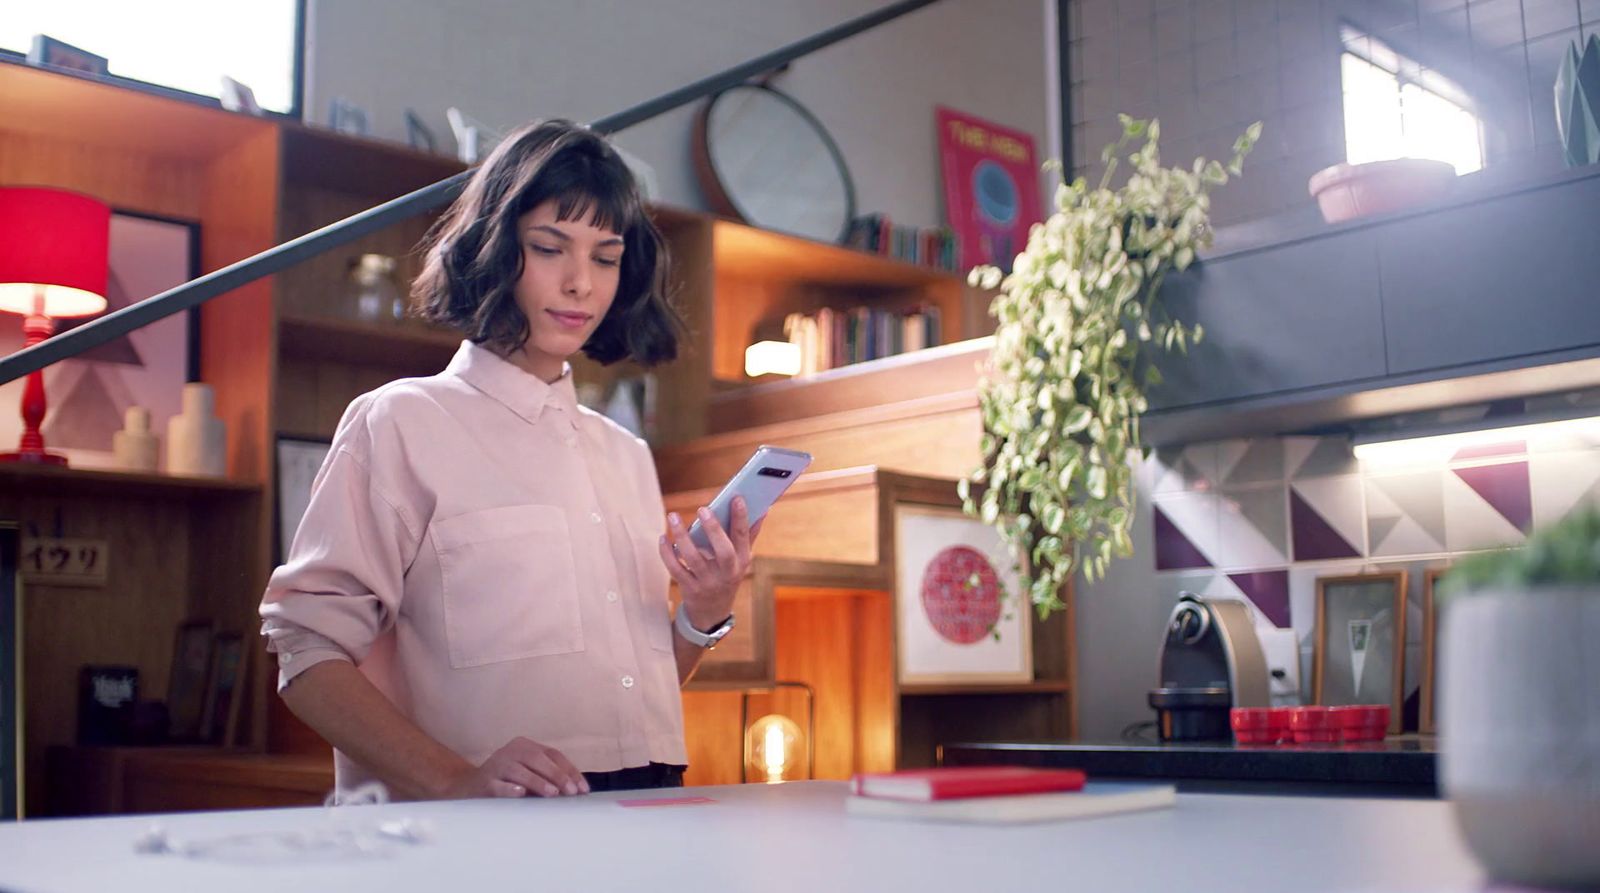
[0,781,1483,893]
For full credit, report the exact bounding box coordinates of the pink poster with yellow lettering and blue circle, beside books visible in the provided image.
[936,106,1042,272]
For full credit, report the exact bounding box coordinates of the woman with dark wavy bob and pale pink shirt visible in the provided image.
[261,122,758,797]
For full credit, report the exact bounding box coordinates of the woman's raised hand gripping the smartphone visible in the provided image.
[661,496,765,629]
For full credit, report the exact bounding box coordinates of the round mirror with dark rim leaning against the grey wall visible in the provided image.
[694,83,856,242]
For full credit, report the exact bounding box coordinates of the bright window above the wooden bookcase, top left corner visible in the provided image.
[0,0,301,114]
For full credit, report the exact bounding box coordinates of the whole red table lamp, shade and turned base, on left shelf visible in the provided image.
[0,186,110,466]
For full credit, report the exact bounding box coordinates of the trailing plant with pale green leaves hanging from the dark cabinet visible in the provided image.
[958,115,1261,616]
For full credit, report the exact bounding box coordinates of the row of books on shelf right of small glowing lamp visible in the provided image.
[784,304,944,374]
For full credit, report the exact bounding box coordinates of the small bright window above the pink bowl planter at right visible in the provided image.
[1339,27,1483,174]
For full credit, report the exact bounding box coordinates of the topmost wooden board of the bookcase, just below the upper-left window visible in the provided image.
[0,62,280,162]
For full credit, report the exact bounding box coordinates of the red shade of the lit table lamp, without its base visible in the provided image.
[0,186,110,317]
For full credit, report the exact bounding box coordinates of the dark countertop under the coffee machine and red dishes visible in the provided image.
[939,735,1438,797]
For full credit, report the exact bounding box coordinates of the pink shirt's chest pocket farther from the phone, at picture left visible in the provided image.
[429,506,584,669]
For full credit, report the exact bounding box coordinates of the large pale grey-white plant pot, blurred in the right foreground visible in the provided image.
[1438,587,1600,890]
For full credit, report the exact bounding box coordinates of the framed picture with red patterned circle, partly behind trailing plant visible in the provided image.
[893,505,1034,685]
